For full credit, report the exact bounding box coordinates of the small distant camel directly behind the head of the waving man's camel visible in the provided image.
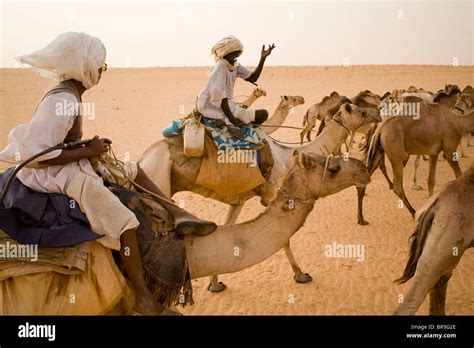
[300,92,351,144]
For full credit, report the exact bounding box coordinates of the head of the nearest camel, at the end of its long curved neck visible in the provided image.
[280,149,370,200]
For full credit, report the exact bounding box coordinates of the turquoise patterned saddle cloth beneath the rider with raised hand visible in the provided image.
[162,117,262,150]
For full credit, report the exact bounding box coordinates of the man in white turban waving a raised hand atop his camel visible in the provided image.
[197,35,275,135]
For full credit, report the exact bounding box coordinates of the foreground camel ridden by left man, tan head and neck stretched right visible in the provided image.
[0,150,370,314]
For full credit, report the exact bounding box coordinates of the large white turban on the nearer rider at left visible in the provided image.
[17,32,106,89]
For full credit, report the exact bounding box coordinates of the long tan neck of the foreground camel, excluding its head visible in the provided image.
[186,193,314,278]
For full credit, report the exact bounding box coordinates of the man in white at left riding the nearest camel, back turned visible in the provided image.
[0,32,216,315]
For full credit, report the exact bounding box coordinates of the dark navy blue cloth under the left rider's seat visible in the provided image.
[0,168,103,247]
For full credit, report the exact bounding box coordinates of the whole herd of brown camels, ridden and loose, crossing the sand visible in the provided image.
[139,85,474,314]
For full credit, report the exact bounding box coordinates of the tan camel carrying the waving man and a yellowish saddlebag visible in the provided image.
[138,104,381,292]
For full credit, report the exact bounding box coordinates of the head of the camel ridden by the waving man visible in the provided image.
[333,103,382,131]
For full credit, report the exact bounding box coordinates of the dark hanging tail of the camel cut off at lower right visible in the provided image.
[395,200,436,284]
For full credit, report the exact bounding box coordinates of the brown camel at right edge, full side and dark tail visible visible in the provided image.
[357,103,474,225]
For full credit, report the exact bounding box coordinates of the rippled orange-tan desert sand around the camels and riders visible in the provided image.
[0,66,474,315]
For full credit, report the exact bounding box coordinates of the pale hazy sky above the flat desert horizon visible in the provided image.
[0,0,474,67]
